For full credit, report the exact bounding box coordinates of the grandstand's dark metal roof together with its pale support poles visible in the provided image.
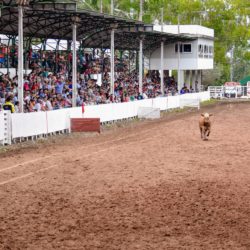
[0,1,214,111]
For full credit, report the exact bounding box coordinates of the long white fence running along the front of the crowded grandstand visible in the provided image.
[0,91,210,144]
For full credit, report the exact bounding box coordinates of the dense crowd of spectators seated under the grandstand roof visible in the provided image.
[0,49,188,112]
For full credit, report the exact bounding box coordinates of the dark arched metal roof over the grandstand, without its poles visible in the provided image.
[0,0,194,50]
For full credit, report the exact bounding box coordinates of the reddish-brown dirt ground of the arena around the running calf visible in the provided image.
[0,100,250,250]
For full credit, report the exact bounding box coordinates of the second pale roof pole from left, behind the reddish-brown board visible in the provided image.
[72,23,77,107]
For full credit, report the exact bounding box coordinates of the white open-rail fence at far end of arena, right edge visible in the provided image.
[208,86,250,99]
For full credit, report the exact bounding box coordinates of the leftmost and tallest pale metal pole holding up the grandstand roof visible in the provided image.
[18,5,23,113]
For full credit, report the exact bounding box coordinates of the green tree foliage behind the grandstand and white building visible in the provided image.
[78,0,250,82]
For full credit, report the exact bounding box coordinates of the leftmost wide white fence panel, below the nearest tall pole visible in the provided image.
[11,112,47,139]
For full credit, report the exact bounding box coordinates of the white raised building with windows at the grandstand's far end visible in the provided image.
[146,25,214,89]
